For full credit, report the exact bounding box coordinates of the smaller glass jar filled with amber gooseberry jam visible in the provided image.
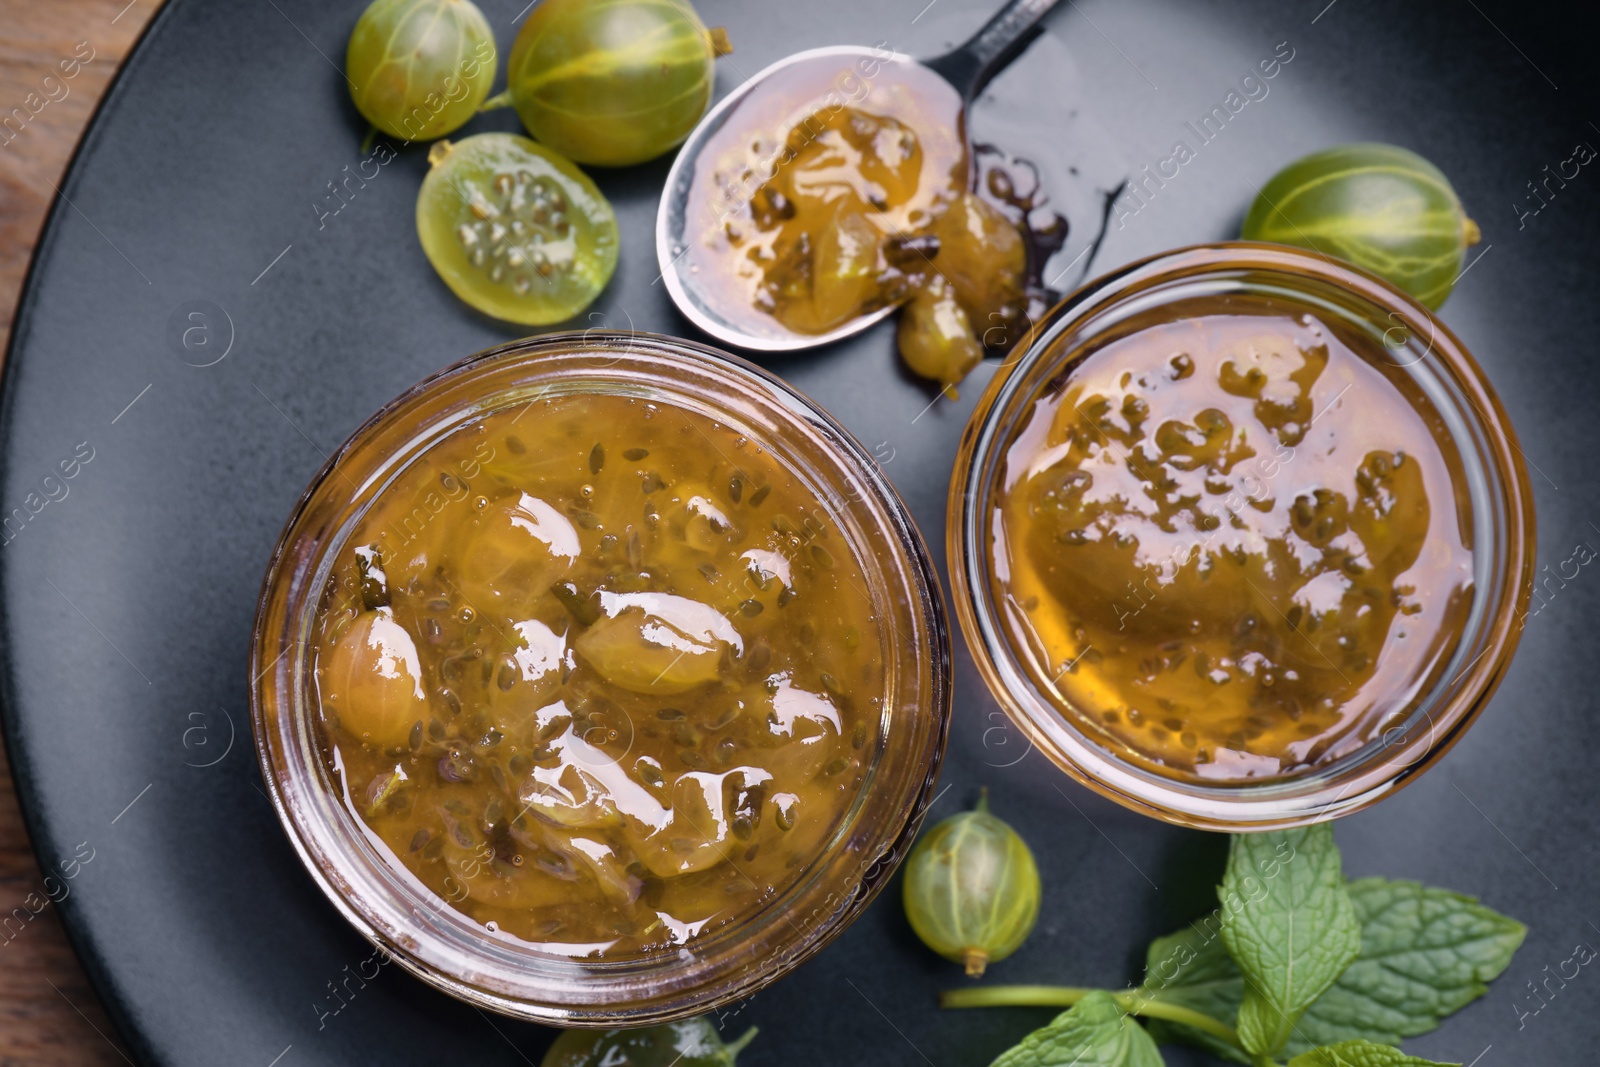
[949,242,1533,832]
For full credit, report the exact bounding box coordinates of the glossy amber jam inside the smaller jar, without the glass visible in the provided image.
[990,299,1472,782]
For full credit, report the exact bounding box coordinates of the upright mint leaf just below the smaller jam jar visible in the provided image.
[1218,822,1362,1056]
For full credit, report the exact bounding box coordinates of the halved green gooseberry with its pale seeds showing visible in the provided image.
[416,133,618,326]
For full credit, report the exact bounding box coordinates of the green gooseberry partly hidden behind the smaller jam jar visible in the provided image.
[1240,144,1480,310]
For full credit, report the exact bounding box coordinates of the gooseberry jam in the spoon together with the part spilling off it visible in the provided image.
[683,50,1027,387]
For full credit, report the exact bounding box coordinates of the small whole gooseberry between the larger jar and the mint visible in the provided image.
[904,789,1040,977]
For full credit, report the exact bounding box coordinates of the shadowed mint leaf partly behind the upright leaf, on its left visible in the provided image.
[1133,912,1250,1064]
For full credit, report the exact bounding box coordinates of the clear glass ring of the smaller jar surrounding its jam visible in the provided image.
[947,242,1534,832]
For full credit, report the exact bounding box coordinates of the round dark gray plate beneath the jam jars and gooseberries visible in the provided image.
[0,0,1600,1067]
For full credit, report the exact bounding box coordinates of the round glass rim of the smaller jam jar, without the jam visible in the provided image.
[946,242,1534,832]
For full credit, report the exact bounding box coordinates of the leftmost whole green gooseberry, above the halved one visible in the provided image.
[344,0,498,141]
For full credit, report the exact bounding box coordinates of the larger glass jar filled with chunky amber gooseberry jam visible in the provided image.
[251,331,950,1027]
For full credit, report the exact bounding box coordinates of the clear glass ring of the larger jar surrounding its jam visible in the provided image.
[251,331,950,1027]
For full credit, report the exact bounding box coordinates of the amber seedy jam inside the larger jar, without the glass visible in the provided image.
[315,395,888,958]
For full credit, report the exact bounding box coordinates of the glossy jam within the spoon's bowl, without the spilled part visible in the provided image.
[685,53,968,333]
